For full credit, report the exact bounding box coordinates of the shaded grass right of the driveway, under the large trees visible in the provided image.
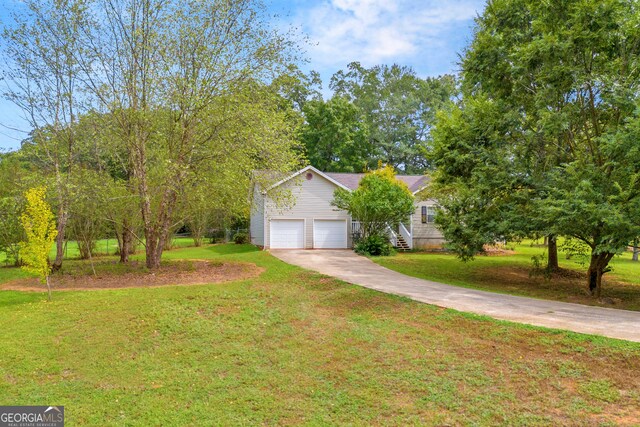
[372,242,640,310]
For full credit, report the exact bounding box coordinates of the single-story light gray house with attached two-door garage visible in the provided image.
[250,166,444,249]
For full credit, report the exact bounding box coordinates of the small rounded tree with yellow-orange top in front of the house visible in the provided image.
[331,166,415,239]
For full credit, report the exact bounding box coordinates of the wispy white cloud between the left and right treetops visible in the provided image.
[294,0,484,68]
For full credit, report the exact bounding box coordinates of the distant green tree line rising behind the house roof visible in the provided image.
[276,62,456,174]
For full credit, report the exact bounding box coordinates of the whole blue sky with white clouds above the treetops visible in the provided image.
[0,0,485,151]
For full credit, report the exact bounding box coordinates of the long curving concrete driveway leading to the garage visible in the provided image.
[271,250,640,342]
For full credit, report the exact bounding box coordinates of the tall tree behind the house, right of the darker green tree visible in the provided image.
[330,62,455,174]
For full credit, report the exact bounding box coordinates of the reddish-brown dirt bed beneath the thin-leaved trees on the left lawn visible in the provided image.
[0,261,264,292]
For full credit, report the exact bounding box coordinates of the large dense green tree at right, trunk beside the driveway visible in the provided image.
[433,0,640,297]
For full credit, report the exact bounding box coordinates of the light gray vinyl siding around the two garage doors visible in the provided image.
[264,171,351,249]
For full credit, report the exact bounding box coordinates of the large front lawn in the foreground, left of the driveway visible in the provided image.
[0,245,640,426]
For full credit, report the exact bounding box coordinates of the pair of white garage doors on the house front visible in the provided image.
[269,219,347,249]
